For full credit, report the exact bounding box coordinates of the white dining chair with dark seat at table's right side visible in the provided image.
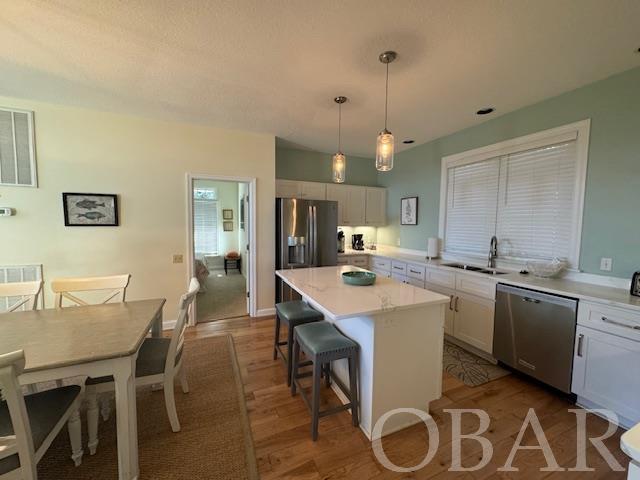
[86,277,200,455]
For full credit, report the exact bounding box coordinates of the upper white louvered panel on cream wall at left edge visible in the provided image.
[0,109,36,186]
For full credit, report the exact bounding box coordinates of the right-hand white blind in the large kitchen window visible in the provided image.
[496,141,576,259]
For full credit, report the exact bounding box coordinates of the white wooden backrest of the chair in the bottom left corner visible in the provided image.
[0,350,37,479]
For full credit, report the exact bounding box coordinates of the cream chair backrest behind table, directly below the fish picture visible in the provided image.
[51,274,131,308]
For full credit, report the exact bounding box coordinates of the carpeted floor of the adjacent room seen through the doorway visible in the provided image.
[196,269,247,322]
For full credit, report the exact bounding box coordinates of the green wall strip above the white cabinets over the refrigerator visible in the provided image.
[276,147,378,186]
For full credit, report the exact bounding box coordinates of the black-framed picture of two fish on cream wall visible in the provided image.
[62,192,118,227]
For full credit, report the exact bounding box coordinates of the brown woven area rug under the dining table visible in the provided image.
[38,335,259,480]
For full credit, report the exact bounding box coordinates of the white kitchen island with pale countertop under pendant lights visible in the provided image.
[276,266,449,440]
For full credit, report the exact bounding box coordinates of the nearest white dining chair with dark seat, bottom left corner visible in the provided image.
[0,350,82,480]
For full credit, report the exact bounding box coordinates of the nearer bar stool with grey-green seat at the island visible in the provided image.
[291,322,360,442]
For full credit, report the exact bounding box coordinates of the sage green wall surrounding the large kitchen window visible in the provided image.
[378,68,640,278]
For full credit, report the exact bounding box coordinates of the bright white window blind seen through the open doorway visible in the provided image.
[193,189,218,255]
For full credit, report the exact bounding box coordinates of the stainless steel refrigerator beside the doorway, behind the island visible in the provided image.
[276,198,338,302]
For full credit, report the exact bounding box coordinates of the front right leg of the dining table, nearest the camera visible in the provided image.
[113,354,139,480]
